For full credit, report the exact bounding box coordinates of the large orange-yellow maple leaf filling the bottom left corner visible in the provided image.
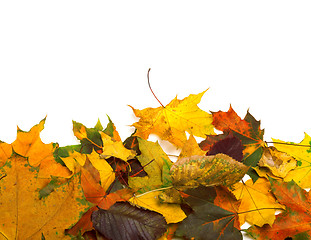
[0,153,91,240]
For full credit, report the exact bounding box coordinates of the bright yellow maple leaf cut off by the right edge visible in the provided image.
[273,133,311,188]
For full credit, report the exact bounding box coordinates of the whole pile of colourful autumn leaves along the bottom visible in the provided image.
[0,91,311,240]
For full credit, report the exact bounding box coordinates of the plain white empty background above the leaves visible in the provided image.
[0,0,311,238]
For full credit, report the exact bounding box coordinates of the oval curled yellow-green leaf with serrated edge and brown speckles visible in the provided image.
[170,153,248,188]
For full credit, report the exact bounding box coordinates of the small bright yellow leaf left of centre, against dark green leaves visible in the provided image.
[100,132,136,161]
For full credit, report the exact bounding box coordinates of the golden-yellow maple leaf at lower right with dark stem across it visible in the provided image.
[233,178,284,227]
